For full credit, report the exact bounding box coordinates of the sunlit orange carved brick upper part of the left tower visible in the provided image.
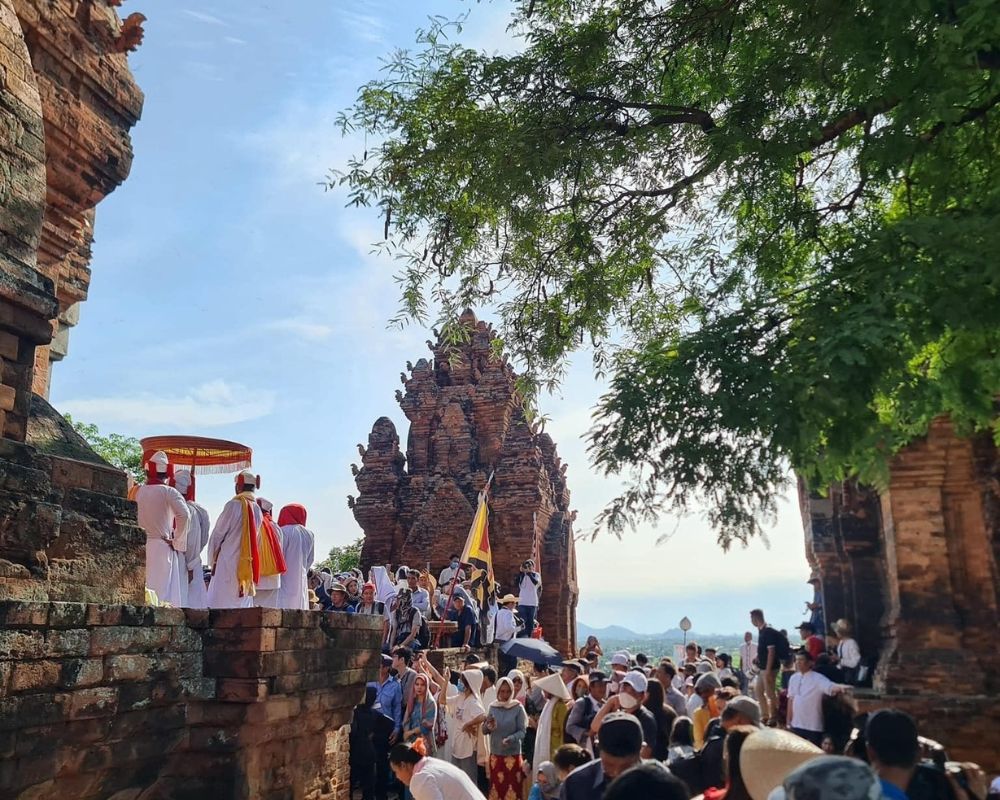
[13,0,145,396]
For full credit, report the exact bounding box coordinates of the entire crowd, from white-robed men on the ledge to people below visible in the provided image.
[135,453,1000,800]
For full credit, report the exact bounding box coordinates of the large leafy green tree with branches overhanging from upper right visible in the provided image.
[340,0,1000,546]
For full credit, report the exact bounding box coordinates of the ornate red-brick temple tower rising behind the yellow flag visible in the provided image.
[349,311,578,652]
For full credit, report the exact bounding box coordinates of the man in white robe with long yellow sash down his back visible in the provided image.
[208,470,263,608]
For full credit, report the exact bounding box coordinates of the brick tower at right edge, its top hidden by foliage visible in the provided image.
[800,418,1000,770]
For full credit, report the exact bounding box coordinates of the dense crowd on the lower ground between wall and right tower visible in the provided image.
[351,609,1000,800]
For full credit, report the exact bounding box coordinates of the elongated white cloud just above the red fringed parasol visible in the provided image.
[60,379,275,430]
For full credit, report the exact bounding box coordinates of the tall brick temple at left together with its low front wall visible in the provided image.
[0,0,381,800]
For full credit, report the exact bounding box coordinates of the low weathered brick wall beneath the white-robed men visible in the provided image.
[0,602,381,800]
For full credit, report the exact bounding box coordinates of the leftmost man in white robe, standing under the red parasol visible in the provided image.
[135,451,191,607]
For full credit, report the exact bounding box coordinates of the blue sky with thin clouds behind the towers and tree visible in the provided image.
[52,0,808,633]
